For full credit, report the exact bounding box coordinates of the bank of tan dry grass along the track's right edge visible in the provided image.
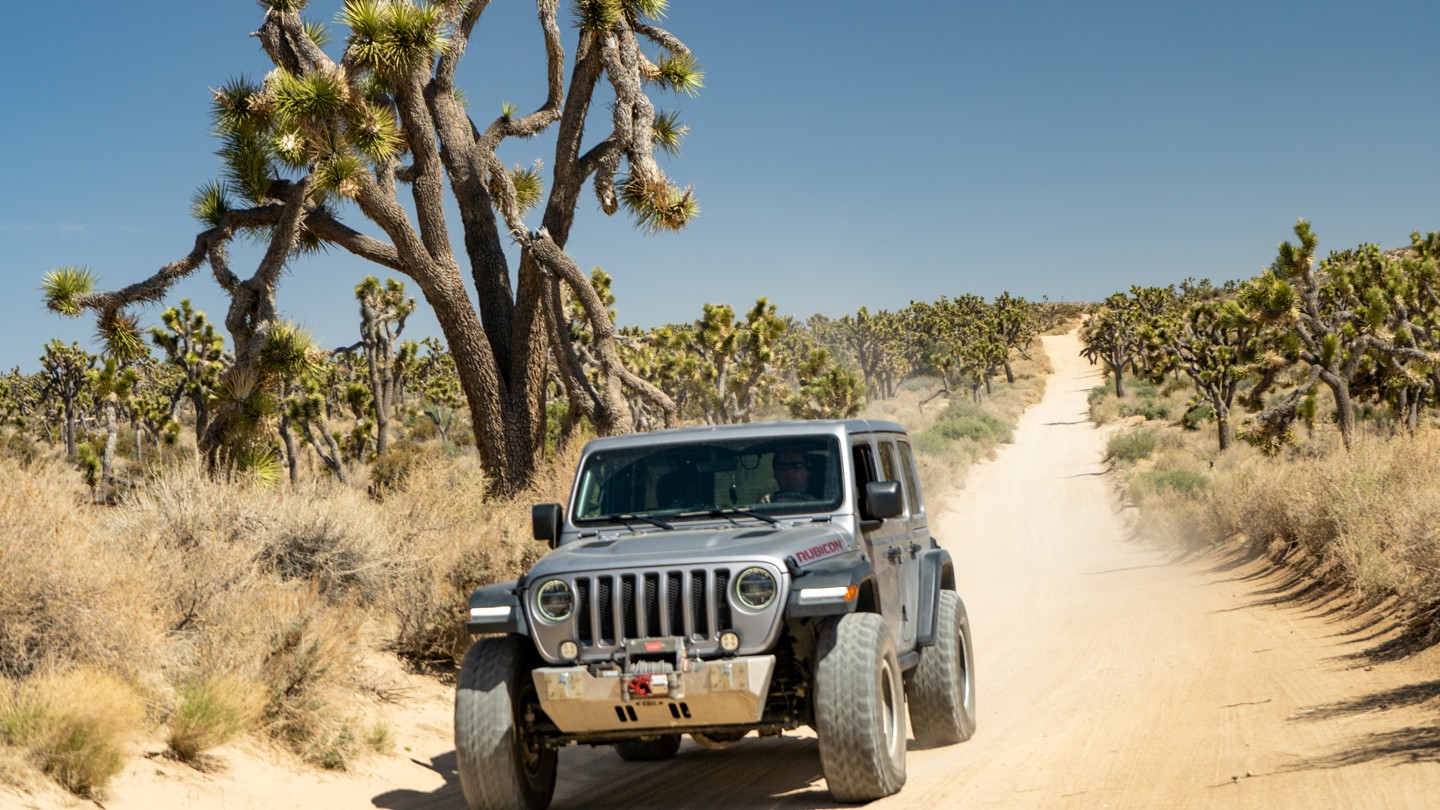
[1128,415,1440,641]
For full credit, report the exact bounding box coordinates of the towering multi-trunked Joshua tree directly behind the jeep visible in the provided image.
[49,0,701,491]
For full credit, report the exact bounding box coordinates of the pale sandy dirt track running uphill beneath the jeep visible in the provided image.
[22,330,1440,810]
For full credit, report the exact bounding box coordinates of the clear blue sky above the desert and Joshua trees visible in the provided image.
[0,0,1440,370]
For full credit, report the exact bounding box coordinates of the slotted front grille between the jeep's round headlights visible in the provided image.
[573,569,730,650]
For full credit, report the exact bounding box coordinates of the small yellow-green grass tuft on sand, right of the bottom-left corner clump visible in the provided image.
[166,675,262,762]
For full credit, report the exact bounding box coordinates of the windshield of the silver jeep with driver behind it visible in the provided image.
[572,435,844,523]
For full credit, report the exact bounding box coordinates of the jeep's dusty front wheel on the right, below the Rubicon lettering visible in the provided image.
[815,613,904,801]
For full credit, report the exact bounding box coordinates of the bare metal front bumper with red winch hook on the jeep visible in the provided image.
[533,656,775,734]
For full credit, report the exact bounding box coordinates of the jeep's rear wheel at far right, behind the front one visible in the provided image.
[909,591,975,748]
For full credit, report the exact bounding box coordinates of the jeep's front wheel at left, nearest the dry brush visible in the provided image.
[455,636,556,810]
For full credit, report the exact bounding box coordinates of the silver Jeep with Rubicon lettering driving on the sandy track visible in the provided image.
[455,419,975,809]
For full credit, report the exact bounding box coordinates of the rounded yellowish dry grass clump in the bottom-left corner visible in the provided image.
[0,667,144,798]
